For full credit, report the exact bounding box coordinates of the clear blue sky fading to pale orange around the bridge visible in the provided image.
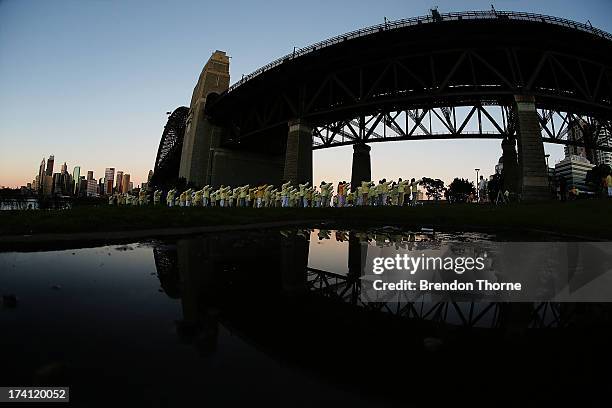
[0,0,612,187]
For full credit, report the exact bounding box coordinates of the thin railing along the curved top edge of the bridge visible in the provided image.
[225,10,612,93]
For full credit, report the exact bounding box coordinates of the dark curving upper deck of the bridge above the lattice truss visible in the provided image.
[207,12,612,155]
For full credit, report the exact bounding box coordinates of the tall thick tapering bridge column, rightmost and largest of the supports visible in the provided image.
[514,95,550,201]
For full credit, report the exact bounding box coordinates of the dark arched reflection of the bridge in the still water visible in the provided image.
[154,231,610,401]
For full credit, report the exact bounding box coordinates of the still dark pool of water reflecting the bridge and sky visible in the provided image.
[0,230,609,406]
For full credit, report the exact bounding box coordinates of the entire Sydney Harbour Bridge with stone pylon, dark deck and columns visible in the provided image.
[155,10,612,200]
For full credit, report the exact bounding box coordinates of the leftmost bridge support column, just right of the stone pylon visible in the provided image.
[283,120,312,185]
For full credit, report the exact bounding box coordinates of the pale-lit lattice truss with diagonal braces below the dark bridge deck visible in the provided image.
[312,102,612,152]
